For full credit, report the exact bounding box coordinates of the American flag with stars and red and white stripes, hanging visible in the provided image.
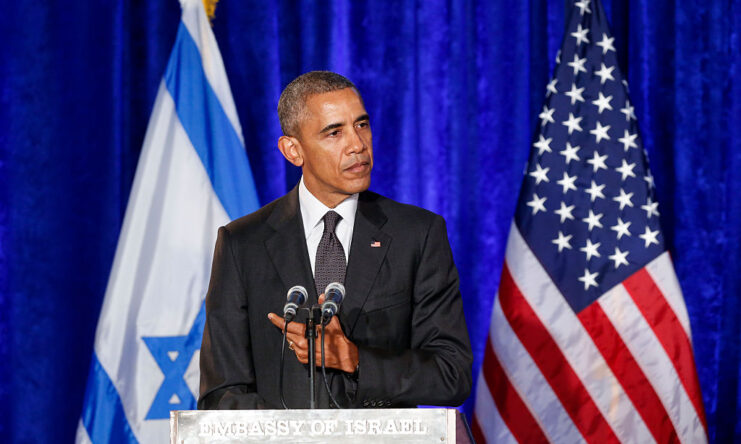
[473,0,707,443]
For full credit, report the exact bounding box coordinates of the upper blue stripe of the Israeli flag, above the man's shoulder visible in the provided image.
[165,22,259,219]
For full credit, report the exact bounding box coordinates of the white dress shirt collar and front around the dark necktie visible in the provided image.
[298,176,358,275]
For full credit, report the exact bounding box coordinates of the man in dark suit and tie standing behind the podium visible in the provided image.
[198,71,472,409]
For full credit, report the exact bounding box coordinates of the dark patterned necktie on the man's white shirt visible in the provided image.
[314,211,347,296]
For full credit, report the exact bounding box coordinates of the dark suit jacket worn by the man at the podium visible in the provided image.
[198,187,472,409]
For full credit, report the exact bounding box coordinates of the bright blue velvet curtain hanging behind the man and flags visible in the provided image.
[0,0,741,443]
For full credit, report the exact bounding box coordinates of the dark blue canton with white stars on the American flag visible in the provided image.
[515,1,664,312]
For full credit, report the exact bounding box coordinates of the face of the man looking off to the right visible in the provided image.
[290,88,373,208]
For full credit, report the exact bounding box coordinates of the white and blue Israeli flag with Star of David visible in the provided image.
[77,0,258,444]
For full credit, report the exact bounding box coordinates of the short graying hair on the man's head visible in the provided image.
[278,71,363,137]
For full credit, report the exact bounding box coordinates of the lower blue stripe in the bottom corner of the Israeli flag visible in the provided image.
[82,353,138,444]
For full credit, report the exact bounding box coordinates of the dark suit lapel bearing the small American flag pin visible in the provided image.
[340,192,391,336]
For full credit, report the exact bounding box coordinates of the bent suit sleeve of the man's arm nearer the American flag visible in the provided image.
[354,216,473,407]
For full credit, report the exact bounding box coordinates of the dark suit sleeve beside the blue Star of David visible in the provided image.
[198,227,265,410]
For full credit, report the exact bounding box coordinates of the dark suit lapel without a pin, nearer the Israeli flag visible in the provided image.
[265,186,317,304]
